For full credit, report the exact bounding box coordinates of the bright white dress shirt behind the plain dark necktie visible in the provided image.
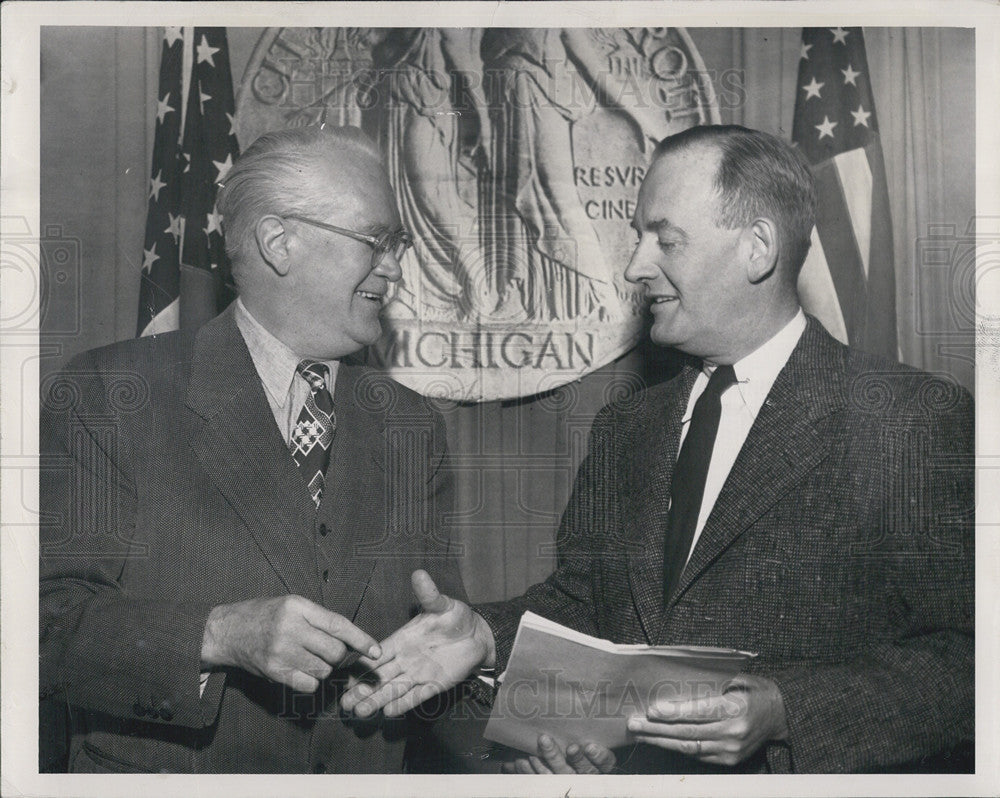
[678,308,806,559]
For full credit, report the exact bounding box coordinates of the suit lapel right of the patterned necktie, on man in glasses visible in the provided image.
[320,362,390,619]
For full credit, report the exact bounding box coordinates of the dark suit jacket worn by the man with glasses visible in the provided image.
[40,311,464,772]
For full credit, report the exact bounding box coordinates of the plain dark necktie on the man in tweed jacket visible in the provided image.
[663,366,736,603]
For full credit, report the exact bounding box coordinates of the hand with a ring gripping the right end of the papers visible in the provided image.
[628,675,788,765]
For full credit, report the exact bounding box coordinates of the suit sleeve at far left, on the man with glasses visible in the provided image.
[39,355,224,727]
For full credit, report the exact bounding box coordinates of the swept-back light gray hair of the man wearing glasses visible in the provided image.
[217,125,382,276]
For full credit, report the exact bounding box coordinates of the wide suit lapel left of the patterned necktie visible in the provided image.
[187,309,321,601]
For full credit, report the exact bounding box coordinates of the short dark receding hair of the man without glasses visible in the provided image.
[654,125,816,277]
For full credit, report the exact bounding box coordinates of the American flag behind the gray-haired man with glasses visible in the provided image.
[137,28,239,335]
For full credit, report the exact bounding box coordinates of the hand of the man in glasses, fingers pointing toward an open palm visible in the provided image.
[201,596,381,693]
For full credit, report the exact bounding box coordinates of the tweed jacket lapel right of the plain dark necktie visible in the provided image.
[664,318,846,615]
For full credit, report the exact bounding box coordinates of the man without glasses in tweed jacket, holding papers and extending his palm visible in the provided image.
[344,127,974,773]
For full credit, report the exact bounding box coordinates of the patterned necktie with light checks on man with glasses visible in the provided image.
[288,360,337,507]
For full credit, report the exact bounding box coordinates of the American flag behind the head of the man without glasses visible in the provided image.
[792,28,898,359]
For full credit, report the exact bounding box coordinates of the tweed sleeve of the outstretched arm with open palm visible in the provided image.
[473,407,619,671]
